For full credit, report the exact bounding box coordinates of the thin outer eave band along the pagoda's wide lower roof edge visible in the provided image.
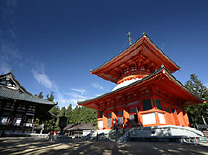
[78,67,204,109]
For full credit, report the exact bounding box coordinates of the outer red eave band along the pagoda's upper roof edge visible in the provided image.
[91,35,181,83]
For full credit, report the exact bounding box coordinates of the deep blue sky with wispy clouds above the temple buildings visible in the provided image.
[0,0,208,107]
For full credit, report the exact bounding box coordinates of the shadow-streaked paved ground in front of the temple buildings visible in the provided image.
[0,137,208,155]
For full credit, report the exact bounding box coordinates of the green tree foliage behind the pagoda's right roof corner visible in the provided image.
[185,74,208,127]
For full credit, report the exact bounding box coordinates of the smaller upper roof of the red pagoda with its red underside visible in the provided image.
[91,34,181,83]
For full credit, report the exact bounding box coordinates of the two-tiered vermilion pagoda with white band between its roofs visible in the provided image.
[78,34,203,129]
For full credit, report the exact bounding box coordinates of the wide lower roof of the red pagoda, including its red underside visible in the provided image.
[78,67,204,109]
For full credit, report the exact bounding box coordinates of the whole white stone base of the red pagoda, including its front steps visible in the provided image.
[82,125,208,143]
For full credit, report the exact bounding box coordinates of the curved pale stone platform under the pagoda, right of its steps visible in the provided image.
[119,125,208,143]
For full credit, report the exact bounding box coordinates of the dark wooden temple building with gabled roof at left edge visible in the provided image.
[0,72,56,136]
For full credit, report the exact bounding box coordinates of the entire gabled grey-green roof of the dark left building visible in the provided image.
[0,72,56,105]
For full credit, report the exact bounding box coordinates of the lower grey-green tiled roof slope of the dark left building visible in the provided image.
[0,87,56,105]
